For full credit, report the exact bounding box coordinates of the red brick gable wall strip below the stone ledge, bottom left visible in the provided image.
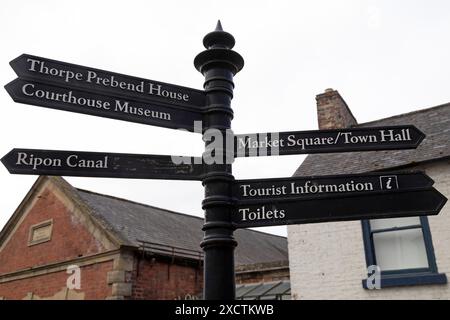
[0,261,113,300]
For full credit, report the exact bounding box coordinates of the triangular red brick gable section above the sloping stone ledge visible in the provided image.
[0,188,104,274]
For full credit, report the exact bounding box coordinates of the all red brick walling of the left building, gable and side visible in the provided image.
[0,179,288,299]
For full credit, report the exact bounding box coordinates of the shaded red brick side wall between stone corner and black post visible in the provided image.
[132,257,203,300]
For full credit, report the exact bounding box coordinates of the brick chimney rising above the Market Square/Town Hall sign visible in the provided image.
[316,89,358,129]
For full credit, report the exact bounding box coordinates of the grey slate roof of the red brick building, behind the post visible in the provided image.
[76,189,288,265]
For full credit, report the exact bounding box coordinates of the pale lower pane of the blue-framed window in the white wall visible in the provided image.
[373,229,428,271]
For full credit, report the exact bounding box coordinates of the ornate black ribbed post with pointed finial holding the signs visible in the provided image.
[194,21,244,300]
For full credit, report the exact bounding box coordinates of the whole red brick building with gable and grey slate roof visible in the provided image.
[0,176,289,299]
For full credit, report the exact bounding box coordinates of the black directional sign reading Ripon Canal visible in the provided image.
[1,149,203,180]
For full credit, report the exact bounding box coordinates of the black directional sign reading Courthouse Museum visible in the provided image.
[5,79,203,133]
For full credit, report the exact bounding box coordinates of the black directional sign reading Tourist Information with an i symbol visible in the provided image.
[232,171,434,204]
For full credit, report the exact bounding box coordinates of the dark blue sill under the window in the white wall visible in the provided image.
[362,273,447,290]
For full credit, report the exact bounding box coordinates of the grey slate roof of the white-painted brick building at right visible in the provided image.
[294,103,450,176]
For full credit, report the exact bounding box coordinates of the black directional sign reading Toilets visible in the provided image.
[232,188,447,228]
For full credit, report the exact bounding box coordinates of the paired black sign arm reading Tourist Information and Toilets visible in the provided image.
[232,172,447,228]
